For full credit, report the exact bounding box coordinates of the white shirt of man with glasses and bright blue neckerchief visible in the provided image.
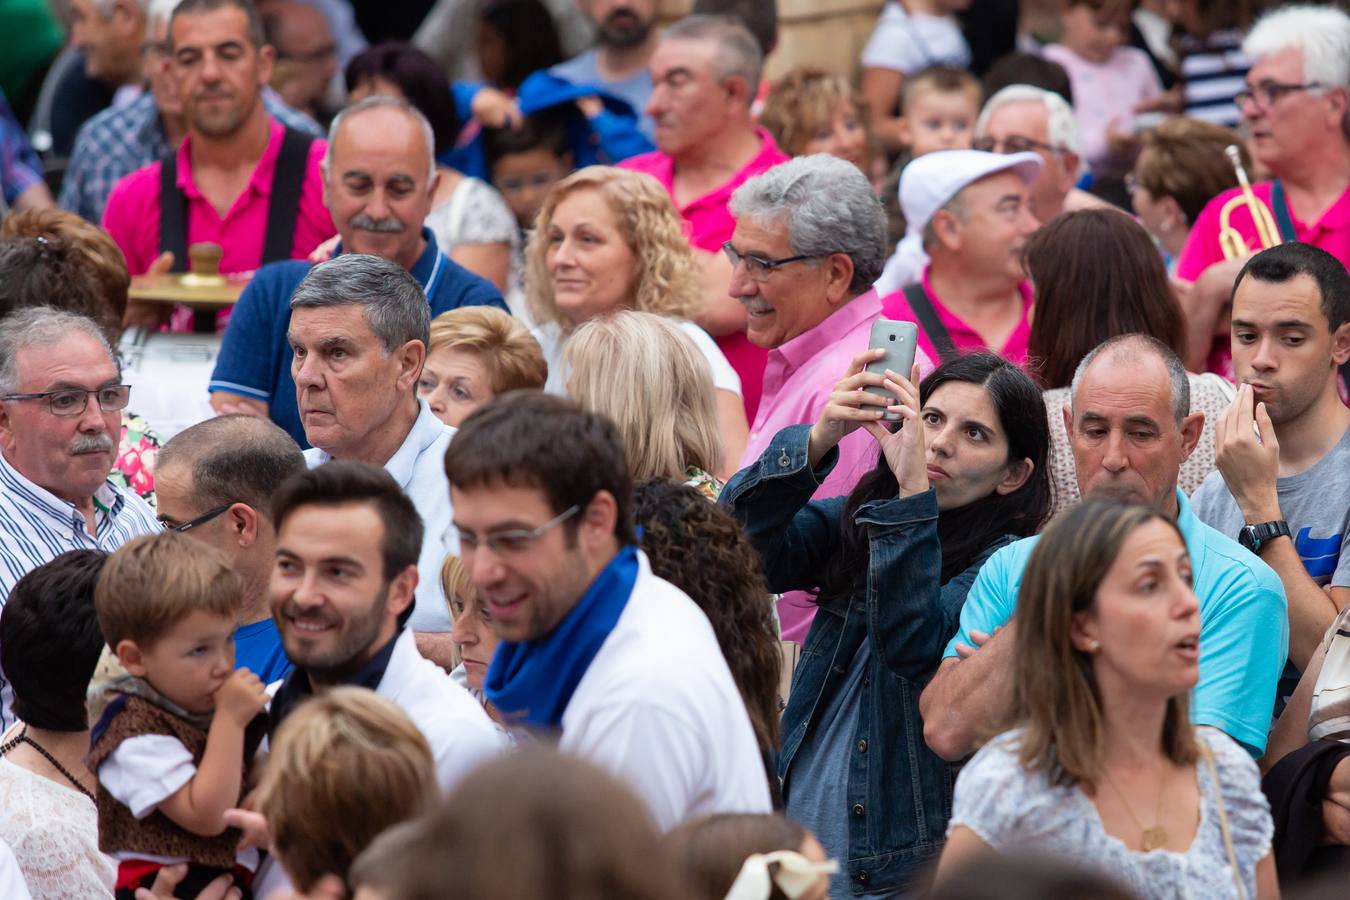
[558,553,771,831]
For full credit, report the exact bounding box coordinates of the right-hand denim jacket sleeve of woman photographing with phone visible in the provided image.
[853,488,1007,681]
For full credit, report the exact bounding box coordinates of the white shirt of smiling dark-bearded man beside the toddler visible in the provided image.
[375,629,506,791]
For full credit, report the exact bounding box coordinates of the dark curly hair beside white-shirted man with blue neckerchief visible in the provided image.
[633,480,783,793]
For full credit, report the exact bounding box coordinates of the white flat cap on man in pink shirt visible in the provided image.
[876,150,1045,294]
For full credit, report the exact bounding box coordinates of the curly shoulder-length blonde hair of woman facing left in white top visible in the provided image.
[525,166,703,333]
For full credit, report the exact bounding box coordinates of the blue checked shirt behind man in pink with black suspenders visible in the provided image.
[58,88,324,225]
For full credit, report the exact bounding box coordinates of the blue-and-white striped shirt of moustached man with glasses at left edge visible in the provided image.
[0,453,161,731]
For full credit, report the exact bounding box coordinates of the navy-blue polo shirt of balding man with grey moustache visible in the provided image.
[208,228,508,448]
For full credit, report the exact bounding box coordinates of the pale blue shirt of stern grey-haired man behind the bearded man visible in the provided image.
[305,399,459,633]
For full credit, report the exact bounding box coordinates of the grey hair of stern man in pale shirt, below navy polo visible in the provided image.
[290,254,431,355]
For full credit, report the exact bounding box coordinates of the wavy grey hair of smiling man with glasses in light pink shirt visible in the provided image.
[730,152,887,294]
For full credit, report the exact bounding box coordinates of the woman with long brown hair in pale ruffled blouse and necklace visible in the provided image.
[937,501,1280,900]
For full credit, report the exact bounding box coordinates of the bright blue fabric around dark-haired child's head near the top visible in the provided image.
[441,69,656,181]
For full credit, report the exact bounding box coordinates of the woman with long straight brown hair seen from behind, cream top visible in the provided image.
[1026,209,1234,513]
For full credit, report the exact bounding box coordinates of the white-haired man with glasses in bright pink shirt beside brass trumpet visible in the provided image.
[1176,4,1350,388]
